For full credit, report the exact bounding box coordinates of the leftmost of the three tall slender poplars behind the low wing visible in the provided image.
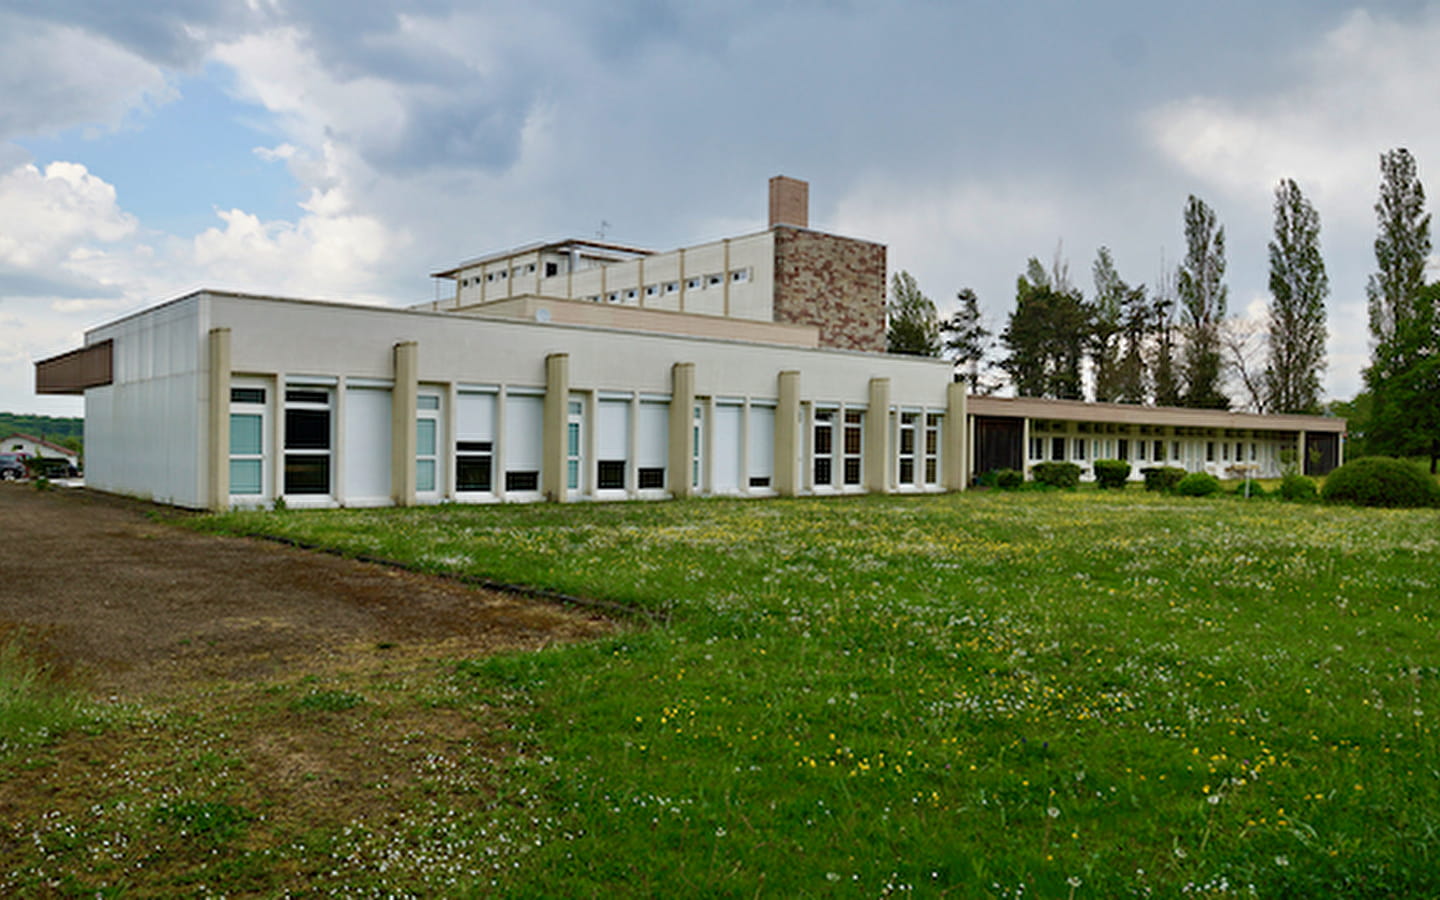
[1176,194,1230,409]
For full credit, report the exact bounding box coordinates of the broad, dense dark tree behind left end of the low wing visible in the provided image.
[999,258,1090,400]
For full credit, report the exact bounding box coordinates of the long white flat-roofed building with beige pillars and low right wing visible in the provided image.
[36,179,1344,510]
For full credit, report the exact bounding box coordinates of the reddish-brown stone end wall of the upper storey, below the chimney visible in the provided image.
[775,226,886,353]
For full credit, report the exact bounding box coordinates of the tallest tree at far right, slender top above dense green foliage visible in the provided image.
[1365,148,1440,474]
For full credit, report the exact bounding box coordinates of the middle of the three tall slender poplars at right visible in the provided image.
[1264,179,1331,413]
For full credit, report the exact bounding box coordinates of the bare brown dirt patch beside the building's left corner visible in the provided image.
[0,482,616,697]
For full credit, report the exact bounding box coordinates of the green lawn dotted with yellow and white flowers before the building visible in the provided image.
[0,491,1440,897]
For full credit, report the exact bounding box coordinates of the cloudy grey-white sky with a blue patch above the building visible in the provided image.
[0,0,1440,416]
